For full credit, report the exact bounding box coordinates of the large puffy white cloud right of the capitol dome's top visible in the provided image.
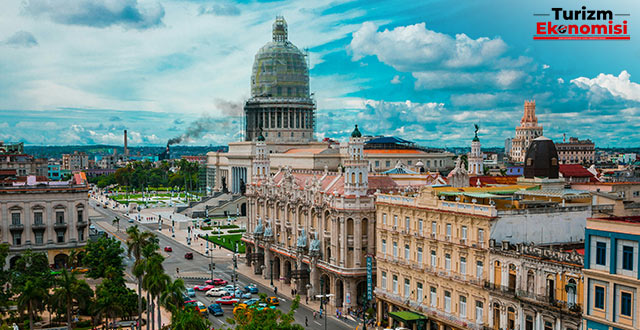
[349,22,507,71]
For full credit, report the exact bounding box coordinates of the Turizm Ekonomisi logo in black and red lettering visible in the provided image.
[533,6,631,40]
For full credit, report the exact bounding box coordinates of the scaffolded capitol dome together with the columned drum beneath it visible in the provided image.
[244,17,316,143]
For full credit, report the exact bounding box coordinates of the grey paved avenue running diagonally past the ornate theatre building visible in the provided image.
[90,201,355,330]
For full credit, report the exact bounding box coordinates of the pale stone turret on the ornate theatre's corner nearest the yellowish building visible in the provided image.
[344,125,369,196]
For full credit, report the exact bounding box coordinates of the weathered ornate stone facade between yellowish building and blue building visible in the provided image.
[485,242,584,330]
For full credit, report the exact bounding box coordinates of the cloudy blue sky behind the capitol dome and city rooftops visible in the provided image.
[0,0,640,147]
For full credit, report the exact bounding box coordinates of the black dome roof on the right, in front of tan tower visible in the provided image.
[524,136,559,179]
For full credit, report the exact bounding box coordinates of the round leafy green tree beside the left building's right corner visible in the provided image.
[82,237,124,278]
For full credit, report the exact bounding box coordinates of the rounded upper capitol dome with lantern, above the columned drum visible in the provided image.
[251,17,309,98]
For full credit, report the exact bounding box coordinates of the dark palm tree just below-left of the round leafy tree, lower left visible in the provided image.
[53,269,93,329]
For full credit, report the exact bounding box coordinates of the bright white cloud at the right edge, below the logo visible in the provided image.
[571,70,640,102]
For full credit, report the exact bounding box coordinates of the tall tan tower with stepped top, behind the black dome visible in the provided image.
[509,101,542,163]
